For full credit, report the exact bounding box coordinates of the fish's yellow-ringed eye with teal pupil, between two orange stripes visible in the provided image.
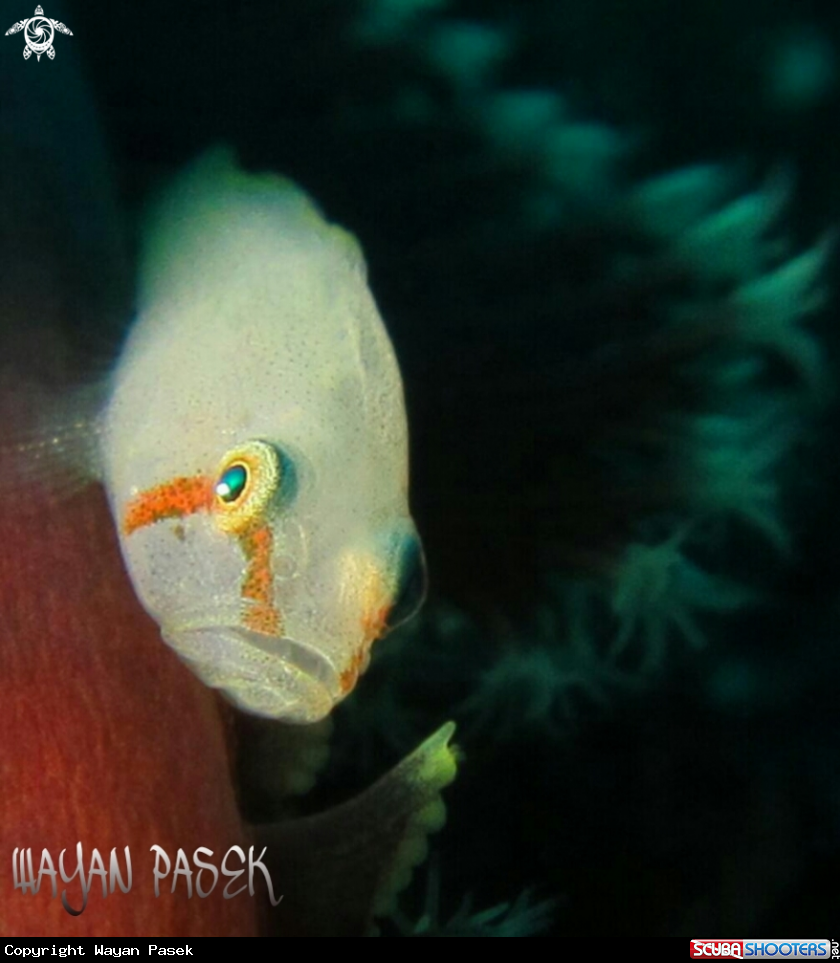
[213,441,283,532]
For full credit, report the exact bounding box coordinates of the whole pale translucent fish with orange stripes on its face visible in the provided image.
[98,151,423,723]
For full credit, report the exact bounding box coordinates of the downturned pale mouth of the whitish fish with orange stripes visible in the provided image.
[162,625,343,725]
